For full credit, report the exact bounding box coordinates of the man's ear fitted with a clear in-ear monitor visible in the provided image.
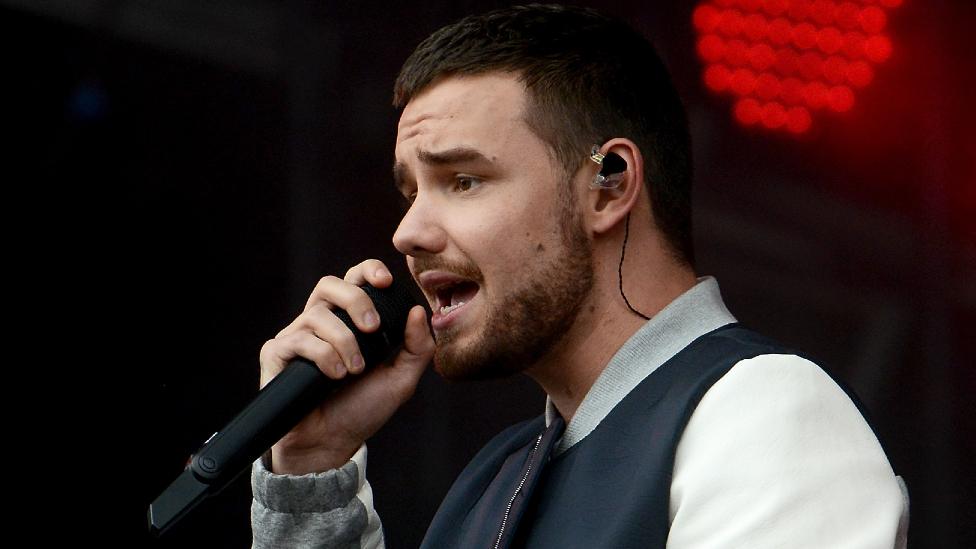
[580,137,644,234]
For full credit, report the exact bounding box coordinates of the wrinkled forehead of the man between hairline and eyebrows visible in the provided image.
[396,73,537,161]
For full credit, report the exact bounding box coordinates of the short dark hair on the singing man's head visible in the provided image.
[393,4,694,265]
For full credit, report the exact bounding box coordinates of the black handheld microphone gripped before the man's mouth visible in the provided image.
[147,281,417,537]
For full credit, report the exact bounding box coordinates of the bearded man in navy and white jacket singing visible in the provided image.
[252,6,907,548]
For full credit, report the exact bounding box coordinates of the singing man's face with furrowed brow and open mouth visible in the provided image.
[393,73,593,378]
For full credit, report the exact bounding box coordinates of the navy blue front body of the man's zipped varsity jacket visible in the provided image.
[422,324,863,549]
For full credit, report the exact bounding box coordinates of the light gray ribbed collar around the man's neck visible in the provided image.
[546,276,736,454]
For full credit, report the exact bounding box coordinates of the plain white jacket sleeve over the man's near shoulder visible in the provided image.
[667,355,908,549]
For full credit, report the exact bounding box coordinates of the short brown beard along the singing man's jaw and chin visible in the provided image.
[434,197,593,380]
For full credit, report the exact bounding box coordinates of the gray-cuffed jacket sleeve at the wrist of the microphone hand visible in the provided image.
[251,445,384,549]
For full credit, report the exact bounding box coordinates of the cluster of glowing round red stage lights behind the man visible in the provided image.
[692,0,902,134]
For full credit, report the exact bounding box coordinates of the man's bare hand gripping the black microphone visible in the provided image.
[261,259,434,475]
